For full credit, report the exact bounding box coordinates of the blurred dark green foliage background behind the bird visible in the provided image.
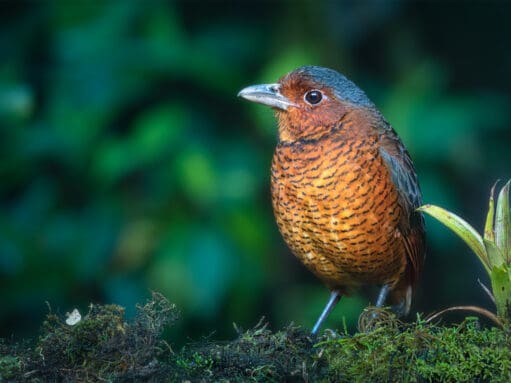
[0,0,511,341]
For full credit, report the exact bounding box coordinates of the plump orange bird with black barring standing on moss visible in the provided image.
[238,66,425,336]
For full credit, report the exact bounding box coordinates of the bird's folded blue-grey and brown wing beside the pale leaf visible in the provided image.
[379,125,425,283]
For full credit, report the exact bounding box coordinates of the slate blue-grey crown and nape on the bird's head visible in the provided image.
[295,65,374,107]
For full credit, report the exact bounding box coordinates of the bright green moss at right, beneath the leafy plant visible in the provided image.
[318,318,511,382]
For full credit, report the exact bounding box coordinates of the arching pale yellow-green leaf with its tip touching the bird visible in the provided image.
[417,205,490,274]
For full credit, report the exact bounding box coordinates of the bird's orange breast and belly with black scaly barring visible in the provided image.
[271,127,407,290]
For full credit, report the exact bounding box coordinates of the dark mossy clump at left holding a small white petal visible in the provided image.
[0,293,177,382]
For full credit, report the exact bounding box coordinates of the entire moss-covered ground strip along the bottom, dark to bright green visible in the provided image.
[0,294,511,383]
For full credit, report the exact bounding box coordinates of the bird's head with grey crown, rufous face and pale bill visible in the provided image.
[238,66,374,142]
